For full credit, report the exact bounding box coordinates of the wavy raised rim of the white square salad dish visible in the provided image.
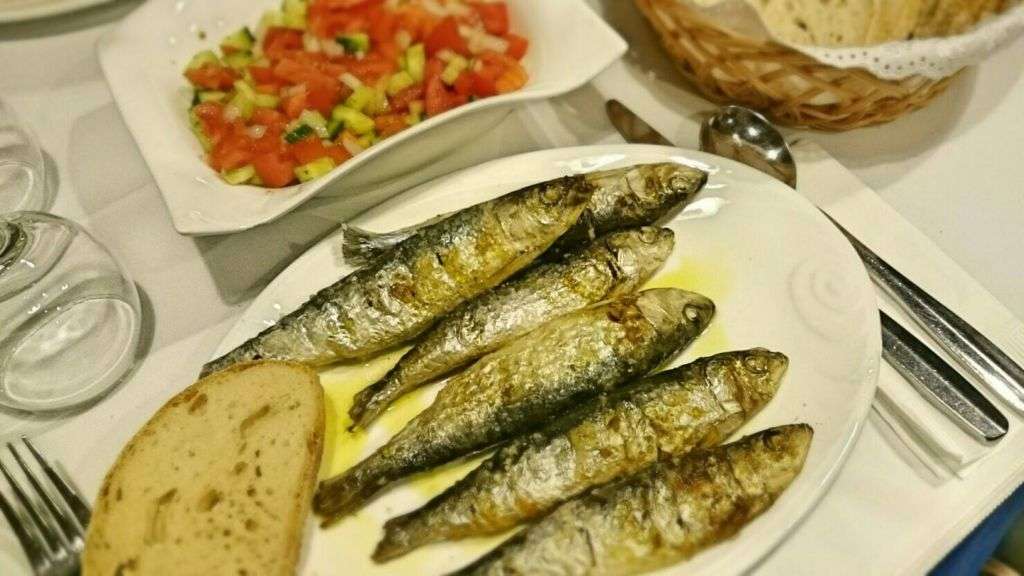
[96,0,629,236]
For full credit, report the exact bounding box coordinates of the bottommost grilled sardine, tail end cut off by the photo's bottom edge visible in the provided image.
[455,424,814,576]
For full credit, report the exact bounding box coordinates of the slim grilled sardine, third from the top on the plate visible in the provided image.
[349,228,674,427]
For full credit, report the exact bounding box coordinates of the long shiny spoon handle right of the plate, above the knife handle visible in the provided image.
[826,214,1024,412]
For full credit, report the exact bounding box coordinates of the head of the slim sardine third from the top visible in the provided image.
[604,227,676,290]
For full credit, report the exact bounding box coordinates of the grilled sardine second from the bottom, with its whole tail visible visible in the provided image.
[374,348,788,562]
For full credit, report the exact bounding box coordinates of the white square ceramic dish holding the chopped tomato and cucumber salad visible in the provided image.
[98,0,627,235]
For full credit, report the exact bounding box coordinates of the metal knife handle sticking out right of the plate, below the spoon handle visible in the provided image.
[879,312,1010,442]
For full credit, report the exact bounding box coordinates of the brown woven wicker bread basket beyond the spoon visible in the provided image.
[636,0,955,131]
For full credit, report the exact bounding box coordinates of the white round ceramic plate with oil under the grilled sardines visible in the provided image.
[215,146,881,575]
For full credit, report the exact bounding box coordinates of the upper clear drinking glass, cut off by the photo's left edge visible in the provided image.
[0,100,46,214]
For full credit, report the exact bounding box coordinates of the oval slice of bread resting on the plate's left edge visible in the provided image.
[82,362,324,576]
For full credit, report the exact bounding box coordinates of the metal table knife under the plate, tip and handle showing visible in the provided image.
[605,99,1010,442]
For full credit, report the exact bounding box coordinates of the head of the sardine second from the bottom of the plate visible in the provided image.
[709,348,790,416]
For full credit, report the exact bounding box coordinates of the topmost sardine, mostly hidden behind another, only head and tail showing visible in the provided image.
[341,162,708,265]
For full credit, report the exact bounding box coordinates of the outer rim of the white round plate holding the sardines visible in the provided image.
[211,143,882,574]
